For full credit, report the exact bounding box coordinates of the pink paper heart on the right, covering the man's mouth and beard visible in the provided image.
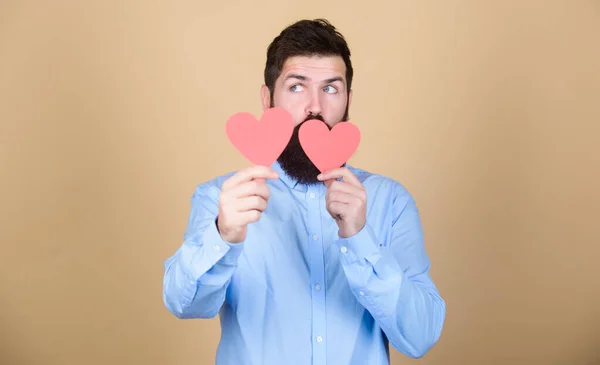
[298,119,360,172]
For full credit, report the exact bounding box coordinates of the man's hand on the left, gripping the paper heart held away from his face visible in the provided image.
[217,166,279,243]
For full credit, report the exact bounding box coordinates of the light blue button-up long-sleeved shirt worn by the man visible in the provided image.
[163,163,446,365]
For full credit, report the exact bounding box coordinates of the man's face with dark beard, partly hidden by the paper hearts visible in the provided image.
[262,56,352,184]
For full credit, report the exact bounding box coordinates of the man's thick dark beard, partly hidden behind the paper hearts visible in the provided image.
[271,99,348,185]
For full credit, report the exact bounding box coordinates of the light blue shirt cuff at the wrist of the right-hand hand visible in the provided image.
[336,223,381,265]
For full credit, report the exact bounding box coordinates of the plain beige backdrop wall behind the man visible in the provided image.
[0,0,600,365]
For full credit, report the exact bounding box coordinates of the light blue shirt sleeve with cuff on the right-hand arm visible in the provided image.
[336,182,446,358]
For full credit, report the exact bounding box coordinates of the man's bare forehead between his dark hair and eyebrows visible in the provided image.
[281,56,346,82]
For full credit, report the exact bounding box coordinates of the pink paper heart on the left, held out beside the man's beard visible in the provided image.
[226,108,294,166]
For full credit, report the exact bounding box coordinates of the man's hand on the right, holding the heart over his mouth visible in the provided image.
[318,167,367,238]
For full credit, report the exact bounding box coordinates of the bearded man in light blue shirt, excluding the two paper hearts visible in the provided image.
[163,19,446,365]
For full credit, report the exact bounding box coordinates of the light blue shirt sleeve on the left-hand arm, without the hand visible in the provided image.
[163,183,244,319]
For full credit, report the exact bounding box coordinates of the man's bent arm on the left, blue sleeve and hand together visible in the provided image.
[163,165,279,318]
